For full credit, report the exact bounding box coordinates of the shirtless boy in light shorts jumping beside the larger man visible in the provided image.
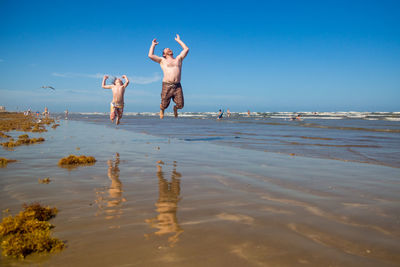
[101,75,129,125]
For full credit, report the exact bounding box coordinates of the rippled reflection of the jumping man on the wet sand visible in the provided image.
[145,161,183,247]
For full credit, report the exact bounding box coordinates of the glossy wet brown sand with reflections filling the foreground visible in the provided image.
[0,121,400,266]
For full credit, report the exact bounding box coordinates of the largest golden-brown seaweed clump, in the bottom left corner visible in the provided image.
[0,203,65,258]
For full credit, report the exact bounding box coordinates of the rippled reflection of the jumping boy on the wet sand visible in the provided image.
[96,153,126,224]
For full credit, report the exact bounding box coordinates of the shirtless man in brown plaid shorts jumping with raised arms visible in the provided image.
[149,34,189,119]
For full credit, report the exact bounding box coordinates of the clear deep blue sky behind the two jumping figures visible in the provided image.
[0,0,400,112]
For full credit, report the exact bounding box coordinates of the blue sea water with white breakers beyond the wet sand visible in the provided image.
[70,112,400,168]
